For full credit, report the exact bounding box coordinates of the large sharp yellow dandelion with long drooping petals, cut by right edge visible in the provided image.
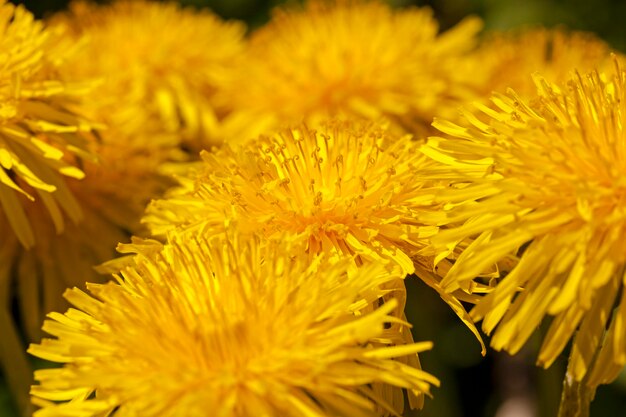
[422,61,626,387]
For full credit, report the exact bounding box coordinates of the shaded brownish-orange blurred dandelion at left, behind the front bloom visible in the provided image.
[0,128,178,415]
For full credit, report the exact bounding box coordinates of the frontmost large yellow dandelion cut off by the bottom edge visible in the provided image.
[29,234,438,417]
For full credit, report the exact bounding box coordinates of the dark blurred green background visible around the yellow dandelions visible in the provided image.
[0,0,626,417]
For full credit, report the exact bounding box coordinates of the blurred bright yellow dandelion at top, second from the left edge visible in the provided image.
[51,0,245,151]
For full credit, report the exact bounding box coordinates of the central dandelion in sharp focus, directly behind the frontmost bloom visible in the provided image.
[144,121,480,352]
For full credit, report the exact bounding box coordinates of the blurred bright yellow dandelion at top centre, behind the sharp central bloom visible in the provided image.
[218,0,483,140]
